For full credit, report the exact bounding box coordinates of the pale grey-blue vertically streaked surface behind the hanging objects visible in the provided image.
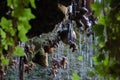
[5,33,101,80]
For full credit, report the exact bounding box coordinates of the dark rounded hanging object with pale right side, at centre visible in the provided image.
[58,22,77,52]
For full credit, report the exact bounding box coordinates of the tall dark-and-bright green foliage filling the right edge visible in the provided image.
[92,0,120,80]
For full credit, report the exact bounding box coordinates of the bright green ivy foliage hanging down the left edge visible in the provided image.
[0,0,35,64]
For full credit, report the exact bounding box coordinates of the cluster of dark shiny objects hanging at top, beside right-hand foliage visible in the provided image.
[68,0,96,36]
